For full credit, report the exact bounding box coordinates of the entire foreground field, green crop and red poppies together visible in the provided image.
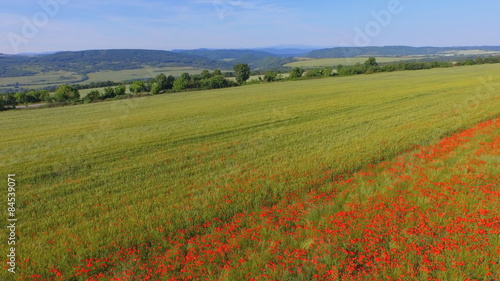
[0,64,500,280]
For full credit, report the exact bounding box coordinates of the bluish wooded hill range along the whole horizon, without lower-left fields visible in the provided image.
[0,46,500,77]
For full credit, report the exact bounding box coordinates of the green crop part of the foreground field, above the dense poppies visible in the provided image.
[0,64,500,280]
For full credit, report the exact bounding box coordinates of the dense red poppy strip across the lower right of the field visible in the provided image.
[40,118,500,280]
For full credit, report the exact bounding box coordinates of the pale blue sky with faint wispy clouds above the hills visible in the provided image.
[0,0,500,54]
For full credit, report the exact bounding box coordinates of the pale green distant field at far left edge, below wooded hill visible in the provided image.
[0,71,83,89]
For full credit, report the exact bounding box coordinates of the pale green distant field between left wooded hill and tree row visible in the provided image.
[85,67,210,83]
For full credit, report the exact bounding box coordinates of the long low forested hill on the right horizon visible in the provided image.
[304,46,500,58]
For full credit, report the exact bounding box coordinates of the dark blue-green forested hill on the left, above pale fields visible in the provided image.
[0,50,232,77]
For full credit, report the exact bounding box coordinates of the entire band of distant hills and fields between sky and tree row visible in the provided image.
[0,46,500,92]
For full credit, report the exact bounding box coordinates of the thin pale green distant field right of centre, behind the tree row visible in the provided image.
[285,57,421,68]
